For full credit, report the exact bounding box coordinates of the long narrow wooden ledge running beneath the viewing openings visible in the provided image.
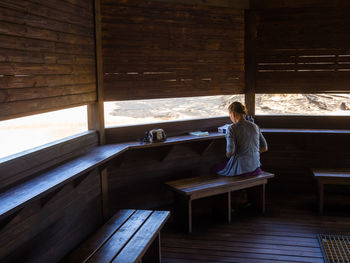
[0,129,350,223]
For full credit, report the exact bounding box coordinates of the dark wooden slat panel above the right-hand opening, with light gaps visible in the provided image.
[256,6,350,93]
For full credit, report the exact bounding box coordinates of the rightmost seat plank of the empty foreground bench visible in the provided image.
[113,211,170,263]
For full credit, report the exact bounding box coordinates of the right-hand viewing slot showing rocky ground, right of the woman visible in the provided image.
[255,93,350,116]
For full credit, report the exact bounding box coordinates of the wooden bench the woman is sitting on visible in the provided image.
[166,172,274,232]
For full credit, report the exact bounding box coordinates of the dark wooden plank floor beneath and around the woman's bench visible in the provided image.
[162,195,350,263]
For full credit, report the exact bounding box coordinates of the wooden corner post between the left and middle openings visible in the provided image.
[88,0,108,218]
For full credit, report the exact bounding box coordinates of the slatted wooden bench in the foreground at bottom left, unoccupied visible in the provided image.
[64,210,170,263]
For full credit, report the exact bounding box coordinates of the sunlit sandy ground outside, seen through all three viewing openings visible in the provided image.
[0,94,350,162]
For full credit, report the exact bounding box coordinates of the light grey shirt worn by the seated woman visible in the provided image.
[218,121,267,176]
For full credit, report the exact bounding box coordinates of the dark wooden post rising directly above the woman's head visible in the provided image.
[244,9,257,116]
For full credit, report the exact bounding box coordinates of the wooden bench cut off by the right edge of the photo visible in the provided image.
[312,169,350,215]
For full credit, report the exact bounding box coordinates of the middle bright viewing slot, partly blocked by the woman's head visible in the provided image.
[104,94,244,127]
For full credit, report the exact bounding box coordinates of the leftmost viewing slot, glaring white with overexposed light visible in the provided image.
[0,106,88,161]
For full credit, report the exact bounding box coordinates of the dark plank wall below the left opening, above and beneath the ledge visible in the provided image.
[0,131,102,262]
